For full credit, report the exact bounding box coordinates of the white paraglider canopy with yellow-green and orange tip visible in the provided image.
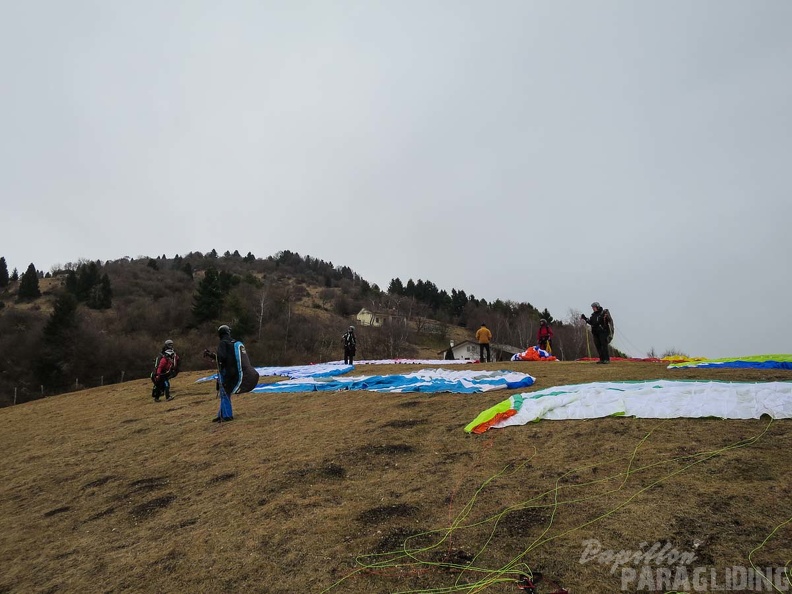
[465,380,792,433]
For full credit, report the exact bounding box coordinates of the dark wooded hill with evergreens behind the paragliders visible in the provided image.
[0,250,620,406]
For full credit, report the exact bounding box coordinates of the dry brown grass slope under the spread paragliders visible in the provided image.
[0,362,792,594]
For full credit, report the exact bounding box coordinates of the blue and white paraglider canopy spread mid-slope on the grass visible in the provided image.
[253,369,535,394]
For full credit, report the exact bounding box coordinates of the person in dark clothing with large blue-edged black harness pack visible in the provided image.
[204,324,259,422]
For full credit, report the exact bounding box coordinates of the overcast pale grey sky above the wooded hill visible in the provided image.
[0,0,792,357]
